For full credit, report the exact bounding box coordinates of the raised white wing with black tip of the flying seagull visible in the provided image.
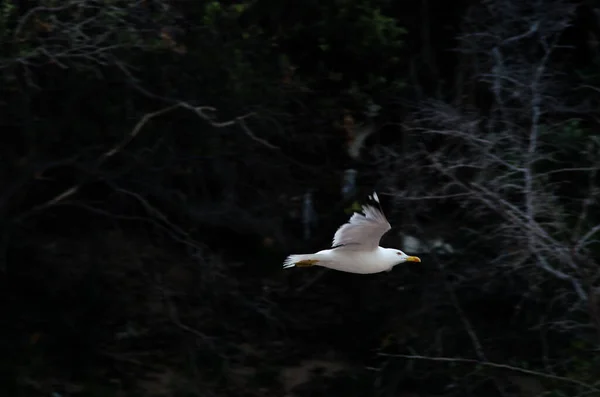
[332,193,392,251]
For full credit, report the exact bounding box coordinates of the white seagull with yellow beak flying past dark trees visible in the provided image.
[283,193,421,274]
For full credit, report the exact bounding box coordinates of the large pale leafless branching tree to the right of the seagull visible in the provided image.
[383,0,600,328]
